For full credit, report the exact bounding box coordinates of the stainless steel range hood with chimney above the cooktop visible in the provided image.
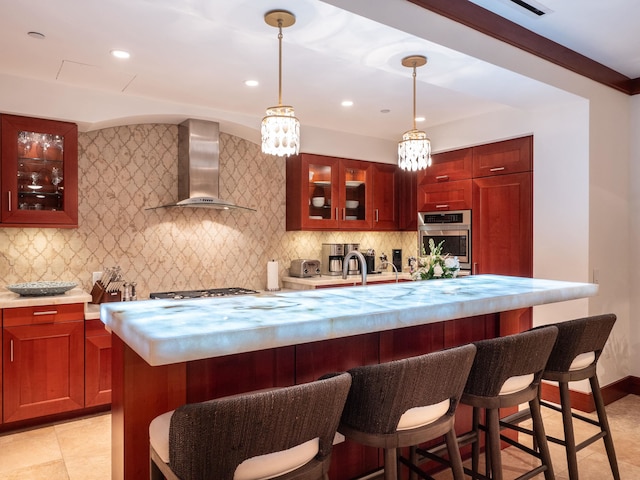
[147,119,255,212]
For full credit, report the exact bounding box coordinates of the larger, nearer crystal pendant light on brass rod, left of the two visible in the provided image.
[262,10,300,157]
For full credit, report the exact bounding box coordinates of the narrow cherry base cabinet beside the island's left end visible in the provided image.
[84,320,112,407]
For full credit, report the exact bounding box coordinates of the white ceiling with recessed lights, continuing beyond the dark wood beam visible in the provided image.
[0,0,640,145]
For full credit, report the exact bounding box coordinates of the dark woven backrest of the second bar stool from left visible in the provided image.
[342,344,476,434]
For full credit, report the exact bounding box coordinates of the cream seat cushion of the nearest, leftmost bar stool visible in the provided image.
[149,410,319,480]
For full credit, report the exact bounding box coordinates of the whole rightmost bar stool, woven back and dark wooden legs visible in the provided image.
[504,314,620,480]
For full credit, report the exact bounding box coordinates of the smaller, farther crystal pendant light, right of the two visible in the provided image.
[398,55,431,171]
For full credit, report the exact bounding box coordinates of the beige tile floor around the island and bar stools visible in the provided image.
[0,395,640,480]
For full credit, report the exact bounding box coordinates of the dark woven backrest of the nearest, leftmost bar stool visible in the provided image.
[169,373,351,480]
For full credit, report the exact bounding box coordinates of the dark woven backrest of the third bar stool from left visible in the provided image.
[464,327,558,398]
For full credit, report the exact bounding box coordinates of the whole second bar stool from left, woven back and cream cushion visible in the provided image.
[338,345,476,480]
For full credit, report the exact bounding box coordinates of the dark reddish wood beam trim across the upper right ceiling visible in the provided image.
[408,0,640,95]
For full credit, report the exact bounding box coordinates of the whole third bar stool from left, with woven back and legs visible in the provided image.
[440,327,558,480]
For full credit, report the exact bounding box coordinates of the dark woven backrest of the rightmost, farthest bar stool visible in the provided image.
[546,313,616,372]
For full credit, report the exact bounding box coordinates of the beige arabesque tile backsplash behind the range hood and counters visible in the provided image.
[0,124,416,298]
